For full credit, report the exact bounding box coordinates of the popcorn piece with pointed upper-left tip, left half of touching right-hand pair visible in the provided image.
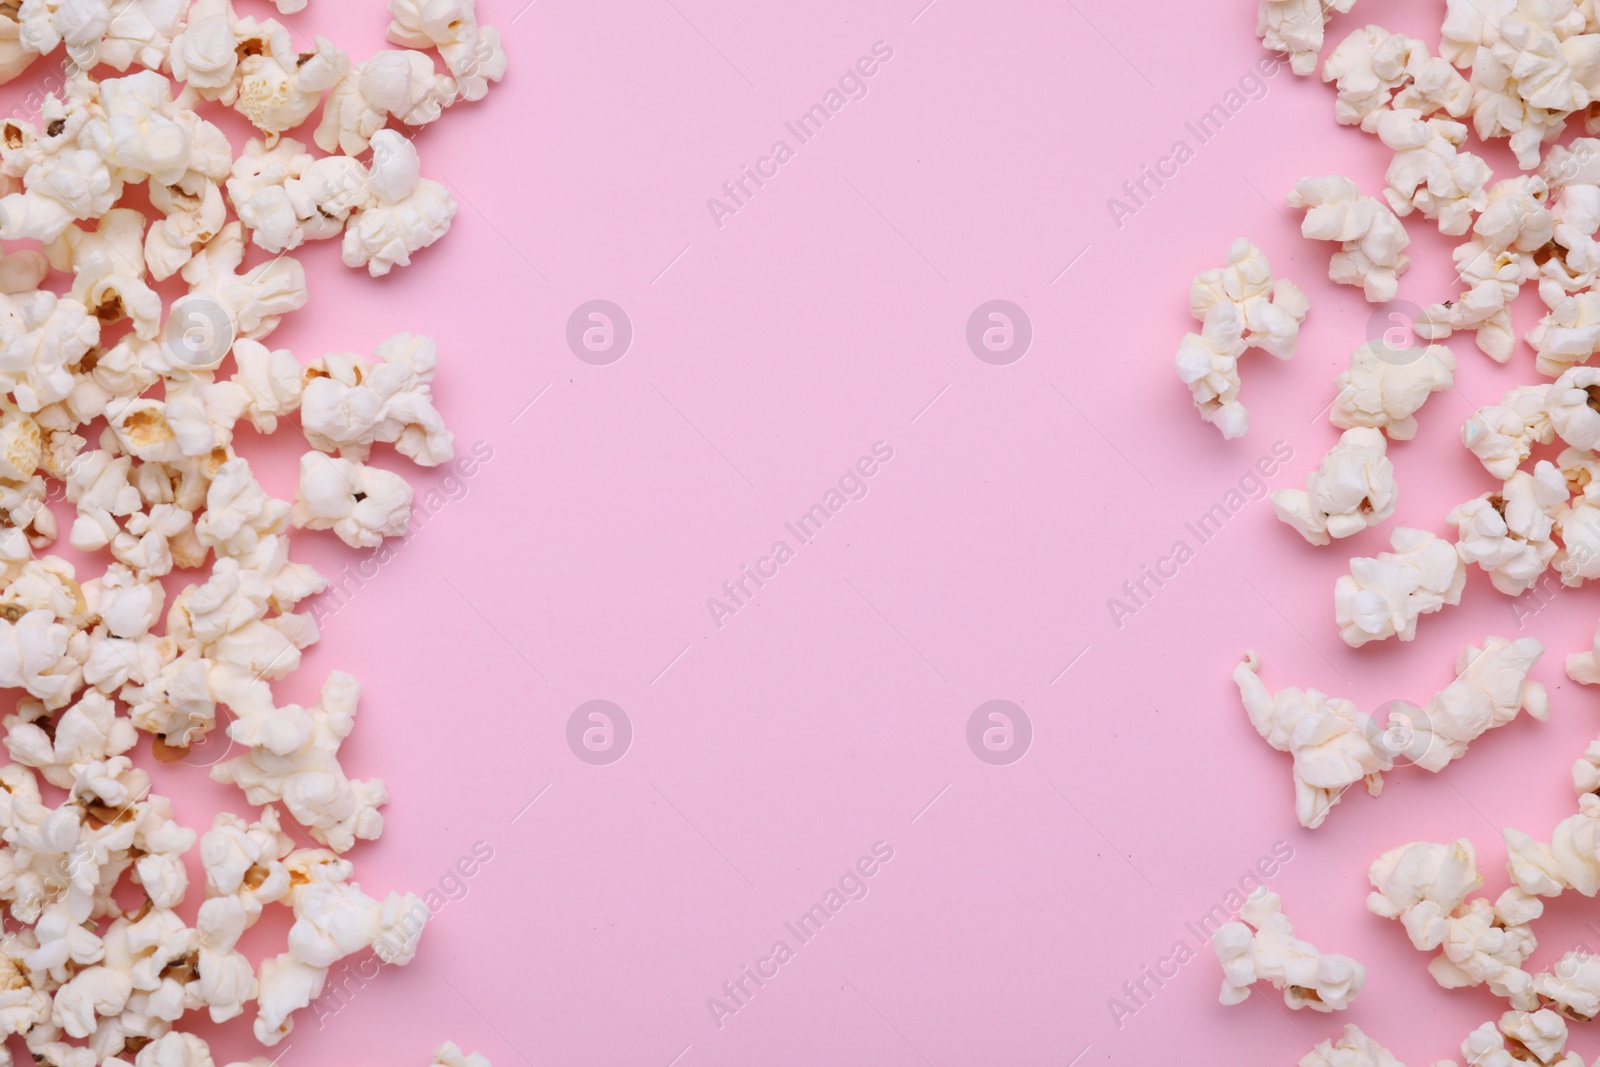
[1234,651,1392,829]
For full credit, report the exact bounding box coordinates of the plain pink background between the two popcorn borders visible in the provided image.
[100,0,1600,1067]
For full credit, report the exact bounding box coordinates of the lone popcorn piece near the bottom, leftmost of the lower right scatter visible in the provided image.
[1211,889,1366,1011]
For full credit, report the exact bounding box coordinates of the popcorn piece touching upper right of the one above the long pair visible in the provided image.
[1445,459,1566,597]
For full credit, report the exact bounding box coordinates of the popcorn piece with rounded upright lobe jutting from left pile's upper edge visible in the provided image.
[344,130,456,278]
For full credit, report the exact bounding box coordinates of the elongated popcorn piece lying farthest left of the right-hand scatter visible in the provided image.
[1174,237,1310,438]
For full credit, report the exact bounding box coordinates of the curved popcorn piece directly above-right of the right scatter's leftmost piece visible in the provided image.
[1288,174,1411,304]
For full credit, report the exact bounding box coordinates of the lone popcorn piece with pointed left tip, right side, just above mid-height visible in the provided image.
[1270,427,1395,544]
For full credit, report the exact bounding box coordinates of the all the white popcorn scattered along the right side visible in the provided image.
[1196,0,1600,1049]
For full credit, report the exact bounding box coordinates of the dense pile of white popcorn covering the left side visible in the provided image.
[0,0,506,1067]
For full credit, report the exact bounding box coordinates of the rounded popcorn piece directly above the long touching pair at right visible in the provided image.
[1333,526,1467,648]
